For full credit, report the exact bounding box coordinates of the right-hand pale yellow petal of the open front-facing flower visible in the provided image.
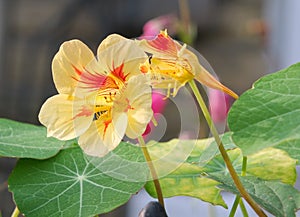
[112,75,153,139]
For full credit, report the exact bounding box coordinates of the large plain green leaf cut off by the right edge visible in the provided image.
[228,63,300,160]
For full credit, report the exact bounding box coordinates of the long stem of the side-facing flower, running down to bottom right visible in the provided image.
[189,80,267,217]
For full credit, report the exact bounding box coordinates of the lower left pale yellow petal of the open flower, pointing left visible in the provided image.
[39,94,94,140]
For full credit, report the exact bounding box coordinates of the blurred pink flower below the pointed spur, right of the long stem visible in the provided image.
[208,88,232,123]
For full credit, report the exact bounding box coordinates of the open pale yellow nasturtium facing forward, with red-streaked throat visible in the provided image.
[39,34,153,157]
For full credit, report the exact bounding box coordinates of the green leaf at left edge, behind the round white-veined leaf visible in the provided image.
[0,118,66,159]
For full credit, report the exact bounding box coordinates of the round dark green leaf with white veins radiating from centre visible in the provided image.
[9,143,145,217]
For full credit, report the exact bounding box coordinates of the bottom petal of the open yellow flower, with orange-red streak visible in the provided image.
[78,112,127,157]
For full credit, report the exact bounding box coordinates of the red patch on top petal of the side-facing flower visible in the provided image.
[148,33,177,56]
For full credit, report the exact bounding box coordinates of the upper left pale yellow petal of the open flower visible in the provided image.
[52,40,94,95]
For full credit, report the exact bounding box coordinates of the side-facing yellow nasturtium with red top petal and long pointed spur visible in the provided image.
[137,30,238,98]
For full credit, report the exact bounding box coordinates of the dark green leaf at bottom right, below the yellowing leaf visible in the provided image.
[212,175,300,217]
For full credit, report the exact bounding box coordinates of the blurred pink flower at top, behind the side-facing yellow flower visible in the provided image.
[140,14,178,39]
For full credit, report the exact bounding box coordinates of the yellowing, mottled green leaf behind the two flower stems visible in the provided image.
[145,134,296,210]
